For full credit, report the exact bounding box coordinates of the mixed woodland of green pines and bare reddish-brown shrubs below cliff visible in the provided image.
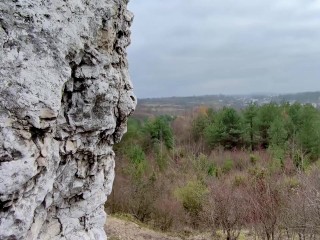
[106,103,320,240]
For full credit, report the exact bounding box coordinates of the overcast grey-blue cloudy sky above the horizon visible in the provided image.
[128,0,320,98]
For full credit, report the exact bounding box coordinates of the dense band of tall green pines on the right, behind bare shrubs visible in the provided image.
[192,103,320,168]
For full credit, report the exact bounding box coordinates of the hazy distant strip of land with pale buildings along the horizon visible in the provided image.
[135,91,320,116]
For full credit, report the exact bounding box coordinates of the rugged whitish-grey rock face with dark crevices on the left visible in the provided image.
[0,0,136,240]
